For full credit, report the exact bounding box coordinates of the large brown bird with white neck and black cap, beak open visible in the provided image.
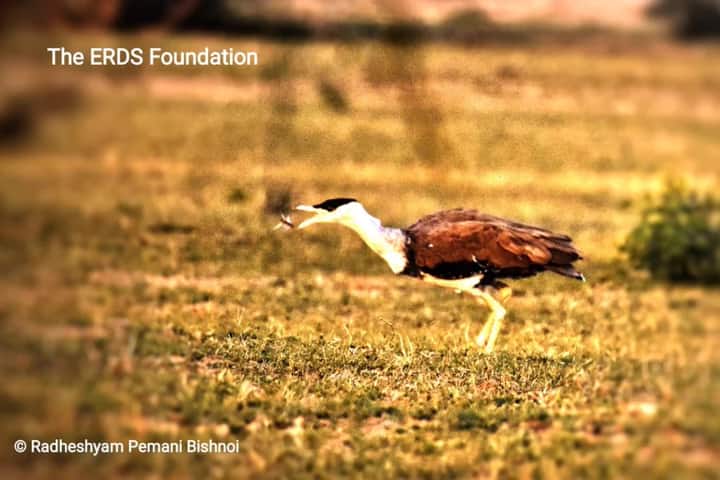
[276,198,585,354]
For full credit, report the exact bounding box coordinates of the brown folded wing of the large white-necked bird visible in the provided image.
[407,209,582,278]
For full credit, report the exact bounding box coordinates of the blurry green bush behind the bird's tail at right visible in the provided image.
[622,184,720,284]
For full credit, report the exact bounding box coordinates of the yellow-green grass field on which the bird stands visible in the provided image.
[0,31,720,478]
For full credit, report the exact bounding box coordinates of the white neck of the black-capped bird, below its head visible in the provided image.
[340,209,407,273]
